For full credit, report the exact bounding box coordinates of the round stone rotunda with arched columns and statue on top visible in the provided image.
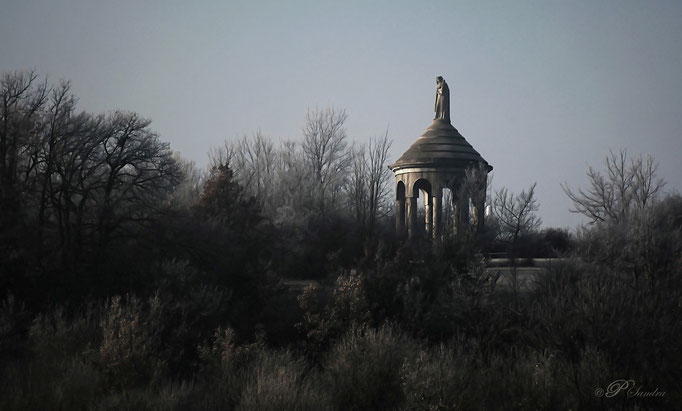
[389,76,493,239]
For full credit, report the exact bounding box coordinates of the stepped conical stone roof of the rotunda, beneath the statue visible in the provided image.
[390,119,493,172]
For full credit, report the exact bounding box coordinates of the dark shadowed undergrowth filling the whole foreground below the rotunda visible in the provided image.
[0,211,682,410]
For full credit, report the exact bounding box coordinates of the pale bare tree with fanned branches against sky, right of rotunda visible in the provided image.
[561,150,665,224]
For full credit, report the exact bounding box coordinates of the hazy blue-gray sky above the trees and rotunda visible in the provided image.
[0,0,682,227]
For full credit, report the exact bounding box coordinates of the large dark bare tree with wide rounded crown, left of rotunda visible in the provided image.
[43,112,181,261]
